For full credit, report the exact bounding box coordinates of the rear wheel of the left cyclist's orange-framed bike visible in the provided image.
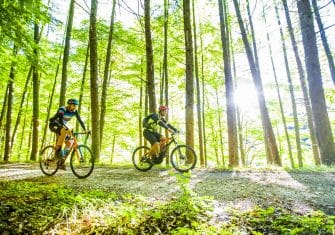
[39,145,58,176]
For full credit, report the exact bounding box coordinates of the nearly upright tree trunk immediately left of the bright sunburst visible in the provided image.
[218,0,239,167]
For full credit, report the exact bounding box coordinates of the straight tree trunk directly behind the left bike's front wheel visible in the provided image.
[89,0,100,162]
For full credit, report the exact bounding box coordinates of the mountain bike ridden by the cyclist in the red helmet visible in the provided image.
[132,134,197,172]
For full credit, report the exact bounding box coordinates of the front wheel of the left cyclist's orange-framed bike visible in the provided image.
[70,145,94,179]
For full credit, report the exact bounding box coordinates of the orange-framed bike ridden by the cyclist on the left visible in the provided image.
[39,132,94,179]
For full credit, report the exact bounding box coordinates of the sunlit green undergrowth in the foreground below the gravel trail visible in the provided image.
[0,175,335,234]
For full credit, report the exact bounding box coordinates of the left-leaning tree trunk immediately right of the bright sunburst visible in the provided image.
[234,0,282,166]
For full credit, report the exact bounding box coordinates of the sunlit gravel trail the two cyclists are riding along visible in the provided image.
[0,164,335,215]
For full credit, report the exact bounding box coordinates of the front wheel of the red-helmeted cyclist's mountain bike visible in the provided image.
[171,145,197,172]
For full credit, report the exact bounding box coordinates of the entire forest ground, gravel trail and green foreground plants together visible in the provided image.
[0,164,335,234]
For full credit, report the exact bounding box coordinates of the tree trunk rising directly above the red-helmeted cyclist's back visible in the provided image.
[144,0,157,113]
